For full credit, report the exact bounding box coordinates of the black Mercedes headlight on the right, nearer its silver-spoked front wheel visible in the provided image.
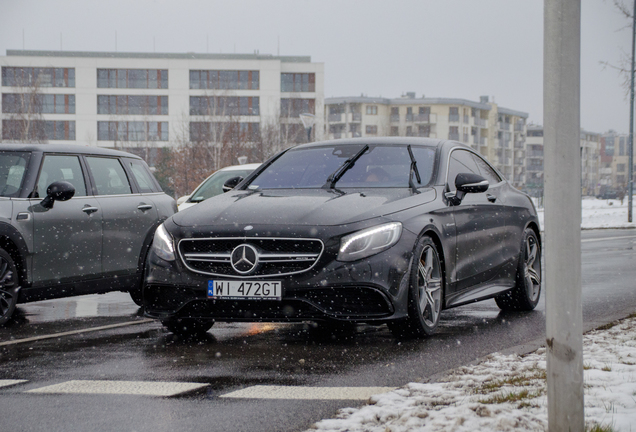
[337,222,402,261]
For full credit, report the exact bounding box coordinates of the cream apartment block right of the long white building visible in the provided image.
[325,93,528,188]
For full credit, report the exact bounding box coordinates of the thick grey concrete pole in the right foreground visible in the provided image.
[543,0,584,432]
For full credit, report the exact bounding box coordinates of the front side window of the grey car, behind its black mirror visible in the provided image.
[36,155,86,198]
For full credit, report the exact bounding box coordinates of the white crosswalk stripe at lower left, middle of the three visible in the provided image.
[27,380,208,397]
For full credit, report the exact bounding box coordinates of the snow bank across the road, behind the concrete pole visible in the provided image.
[535,197,636,229]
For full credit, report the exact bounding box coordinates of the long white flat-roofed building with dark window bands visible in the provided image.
[0,50,324,152]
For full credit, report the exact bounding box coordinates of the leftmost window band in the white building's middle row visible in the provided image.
[2,93,75,114]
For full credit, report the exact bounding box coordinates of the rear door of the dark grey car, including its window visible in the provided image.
[86,156,157,275]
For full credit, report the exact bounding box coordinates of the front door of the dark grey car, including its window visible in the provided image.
[29,154,102,284]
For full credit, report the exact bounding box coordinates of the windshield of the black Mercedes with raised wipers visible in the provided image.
[248,143,435,189]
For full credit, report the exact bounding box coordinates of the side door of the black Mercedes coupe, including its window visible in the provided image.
[447,149,506,291]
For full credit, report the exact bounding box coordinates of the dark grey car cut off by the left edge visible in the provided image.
[0,144,177,324]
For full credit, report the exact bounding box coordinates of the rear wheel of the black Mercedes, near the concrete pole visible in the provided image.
[495,228,541,311]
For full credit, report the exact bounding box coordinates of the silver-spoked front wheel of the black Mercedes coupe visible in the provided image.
[388,236,444,339]
